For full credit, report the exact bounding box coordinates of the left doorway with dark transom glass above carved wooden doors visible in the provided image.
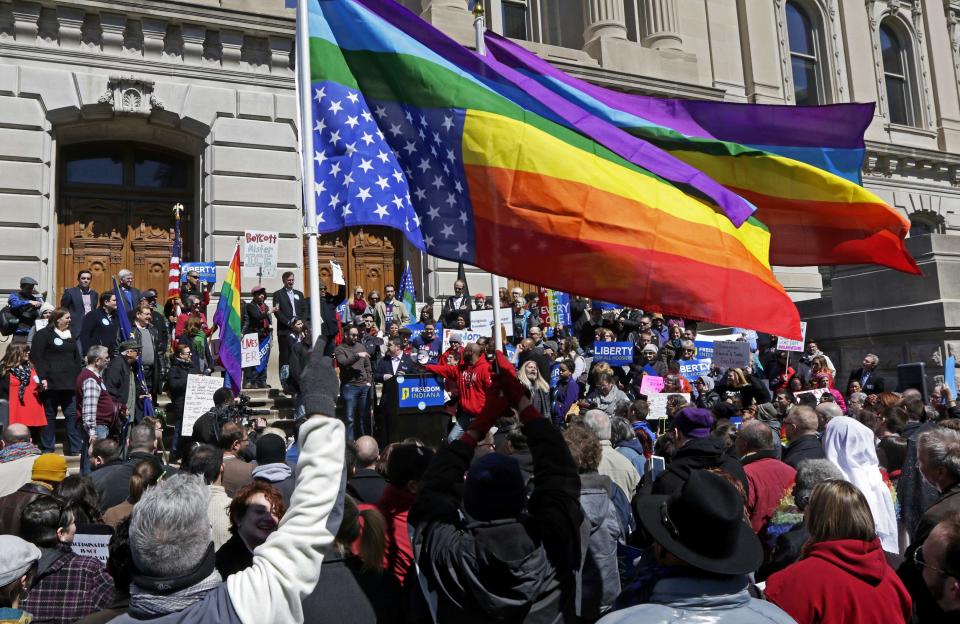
[57,142,194,301]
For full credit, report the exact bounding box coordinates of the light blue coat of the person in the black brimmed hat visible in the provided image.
[598,575,794,624]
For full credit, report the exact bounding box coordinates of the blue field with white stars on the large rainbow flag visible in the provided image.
[313,82,474,263]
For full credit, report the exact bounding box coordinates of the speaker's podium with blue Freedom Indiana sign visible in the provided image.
[378,373,450,448]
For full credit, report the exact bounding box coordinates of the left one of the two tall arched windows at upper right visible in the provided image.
[786,1,827,105]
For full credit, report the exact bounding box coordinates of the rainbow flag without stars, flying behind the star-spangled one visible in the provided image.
[485,32,919,273]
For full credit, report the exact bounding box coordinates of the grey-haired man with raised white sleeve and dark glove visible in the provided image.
[111,337,346,624]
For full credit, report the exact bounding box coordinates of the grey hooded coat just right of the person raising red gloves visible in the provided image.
[577,473,628,621]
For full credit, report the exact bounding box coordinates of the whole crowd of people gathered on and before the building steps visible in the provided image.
[0,272,960,624]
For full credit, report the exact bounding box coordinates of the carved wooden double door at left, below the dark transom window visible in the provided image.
[56,196,189,303]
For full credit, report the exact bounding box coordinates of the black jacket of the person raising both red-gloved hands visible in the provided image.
[409,418,583,624]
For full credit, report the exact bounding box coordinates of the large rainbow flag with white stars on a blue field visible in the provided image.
[309,0,799,337]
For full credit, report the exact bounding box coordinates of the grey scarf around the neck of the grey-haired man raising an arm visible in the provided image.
[129,542,223,619]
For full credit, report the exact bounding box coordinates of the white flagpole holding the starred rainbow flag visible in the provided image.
[296,0,322,344]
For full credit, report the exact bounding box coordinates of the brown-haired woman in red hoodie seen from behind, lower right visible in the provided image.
[765,480,912,624]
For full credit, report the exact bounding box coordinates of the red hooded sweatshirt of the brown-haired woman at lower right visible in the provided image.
[765,539,912,624]
